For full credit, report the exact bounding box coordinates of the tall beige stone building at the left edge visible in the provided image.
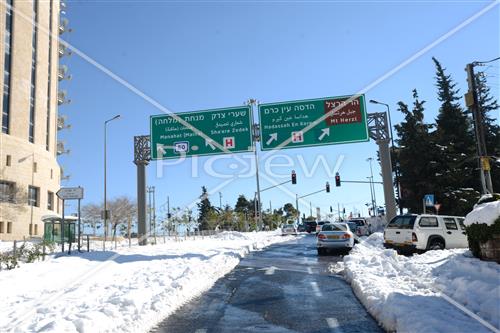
[0,0,62,240]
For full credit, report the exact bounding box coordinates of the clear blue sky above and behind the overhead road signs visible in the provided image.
[59,1,500,219]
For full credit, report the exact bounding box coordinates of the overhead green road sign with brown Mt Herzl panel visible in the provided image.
[259,95,369,150]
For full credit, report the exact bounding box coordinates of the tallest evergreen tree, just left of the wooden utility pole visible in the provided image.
[432,58,480,215]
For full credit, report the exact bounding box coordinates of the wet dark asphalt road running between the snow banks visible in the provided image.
[152,235,383,333]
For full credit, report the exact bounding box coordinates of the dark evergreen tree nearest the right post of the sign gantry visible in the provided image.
[394,89,436,213]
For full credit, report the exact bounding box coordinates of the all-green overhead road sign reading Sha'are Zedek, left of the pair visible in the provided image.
[150,106,252,160]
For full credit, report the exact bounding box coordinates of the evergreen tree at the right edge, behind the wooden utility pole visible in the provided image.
[475,72,500,192]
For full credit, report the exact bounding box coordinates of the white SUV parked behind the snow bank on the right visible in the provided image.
[384,214,468,252]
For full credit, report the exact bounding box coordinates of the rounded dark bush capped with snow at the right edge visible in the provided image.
[464,194,500,262]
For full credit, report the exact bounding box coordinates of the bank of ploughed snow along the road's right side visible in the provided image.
[342,233,500,333]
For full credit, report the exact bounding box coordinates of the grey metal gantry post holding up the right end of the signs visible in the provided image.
[368,112,397,223]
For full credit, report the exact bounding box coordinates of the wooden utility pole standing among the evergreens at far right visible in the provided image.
[465,62,493,194]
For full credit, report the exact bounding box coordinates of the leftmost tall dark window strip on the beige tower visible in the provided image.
[2,0,12,134]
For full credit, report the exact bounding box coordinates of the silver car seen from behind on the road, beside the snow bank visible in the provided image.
[316,223,354,255]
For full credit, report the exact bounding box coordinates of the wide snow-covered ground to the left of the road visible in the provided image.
[0,232,293,332]
